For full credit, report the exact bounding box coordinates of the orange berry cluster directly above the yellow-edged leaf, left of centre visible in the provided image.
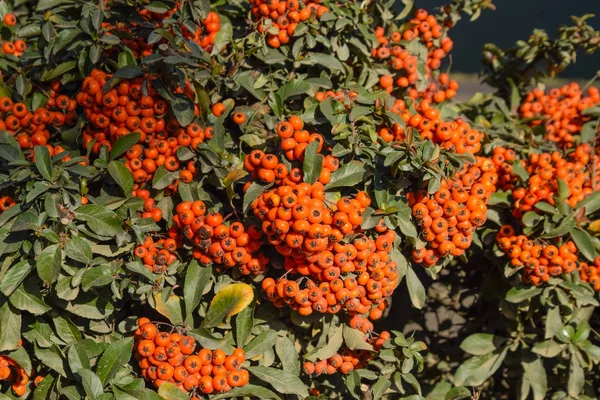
[173,200,269,275]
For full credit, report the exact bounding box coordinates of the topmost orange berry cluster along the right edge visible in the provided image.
[519,82,600,148]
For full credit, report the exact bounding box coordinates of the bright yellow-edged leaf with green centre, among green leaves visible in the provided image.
[202,283,254,328]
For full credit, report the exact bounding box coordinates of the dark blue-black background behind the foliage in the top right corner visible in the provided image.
[398,0,600,80]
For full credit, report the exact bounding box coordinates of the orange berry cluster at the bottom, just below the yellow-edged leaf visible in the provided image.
[134,318,250,400]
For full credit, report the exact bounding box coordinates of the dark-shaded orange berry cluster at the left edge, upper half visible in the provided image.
[0,90,77,150]
